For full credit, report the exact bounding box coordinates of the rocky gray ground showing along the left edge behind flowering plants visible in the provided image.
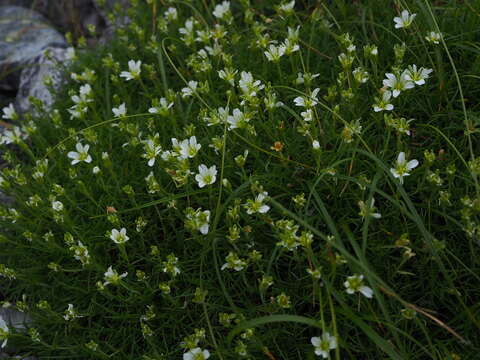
[0,0,128,360]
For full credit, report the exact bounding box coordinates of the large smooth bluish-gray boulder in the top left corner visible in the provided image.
[0,6,67,91]
